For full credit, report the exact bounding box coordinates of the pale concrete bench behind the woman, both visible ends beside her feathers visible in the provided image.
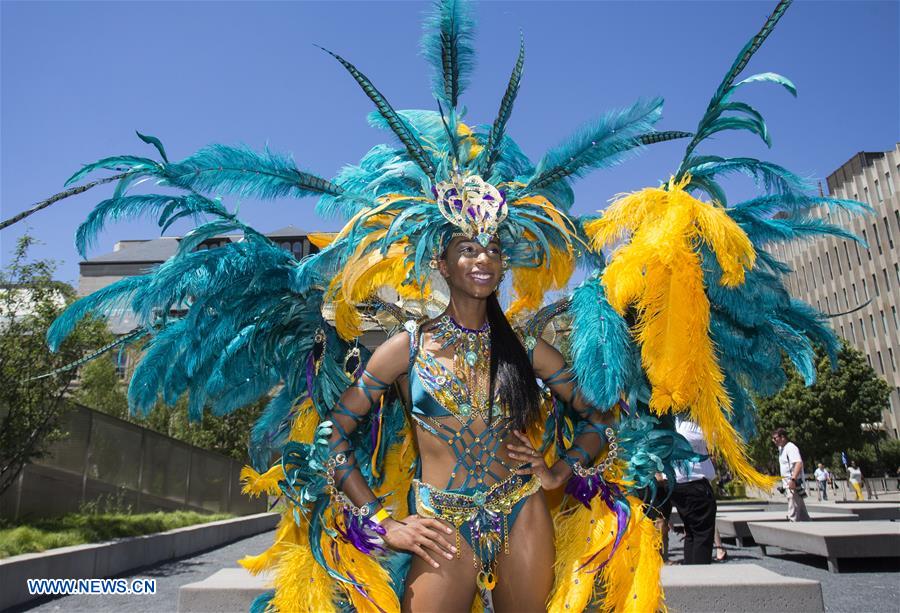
[178,564,824,613]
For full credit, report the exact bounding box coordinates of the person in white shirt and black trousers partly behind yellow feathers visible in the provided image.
[672,420,716,564]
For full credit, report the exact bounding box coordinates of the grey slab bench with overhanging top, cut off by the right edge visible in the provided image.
[749,521,900,573]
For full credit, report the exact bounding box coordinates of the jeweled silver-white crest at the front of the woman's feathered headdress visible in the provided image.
[434,174,509,247]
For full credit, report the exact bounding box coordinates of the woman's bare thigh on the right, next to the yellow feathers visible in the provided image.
[493,490,556,613]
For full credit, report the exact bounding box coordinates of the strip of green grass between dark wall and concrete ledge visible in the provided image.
[0,511,234,558]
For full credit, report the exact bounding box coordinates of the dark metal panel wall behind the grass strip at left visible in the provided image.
[0,405,266,519]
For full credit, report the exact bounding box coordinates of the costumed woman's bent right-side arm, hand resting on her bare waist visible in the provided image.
[509,340,613,489]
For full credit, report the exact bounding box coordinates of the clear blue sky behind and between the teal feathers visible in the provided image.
[0,0,900,281]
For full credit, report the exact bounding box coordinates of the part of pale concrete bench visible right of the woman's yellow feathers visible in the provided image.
[662,564,825,613]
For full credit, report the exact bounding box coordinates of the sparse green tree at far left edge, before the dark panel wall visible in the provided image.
[0,235,109,493]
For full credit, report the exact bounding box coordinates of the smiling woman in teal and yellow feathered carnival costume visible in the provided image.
[14,0,863,611]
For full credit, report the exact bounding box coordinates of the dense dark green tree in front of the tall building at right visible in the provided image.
[750,342,890,473]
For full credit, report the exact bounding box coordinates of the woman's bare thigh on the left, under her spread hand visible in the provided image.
[403,524,478,613]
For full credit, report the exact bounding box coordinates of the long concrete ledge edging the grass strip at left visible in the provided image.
[0,513,279,610]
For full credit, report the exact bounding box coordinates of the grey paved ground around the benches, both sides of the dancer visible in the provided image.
[18,532,900,613]
